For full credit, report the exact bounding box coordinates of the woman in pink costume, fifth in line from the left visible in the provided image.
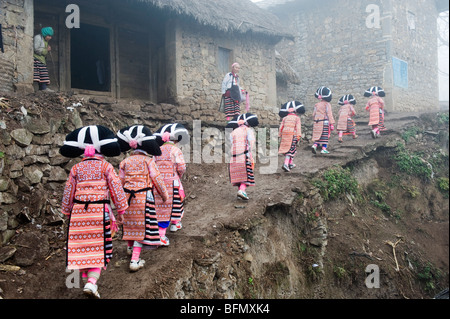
[278,101,305,172]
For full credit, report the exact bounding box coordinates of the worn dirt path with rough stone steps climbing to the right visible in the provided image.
[172,114,419,240]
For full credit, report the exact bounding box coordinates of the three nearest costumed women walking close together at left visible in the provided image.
[60,123,188,298]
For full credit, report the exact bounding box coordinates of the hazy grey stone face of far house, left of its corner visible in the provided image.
[274,0,387,112]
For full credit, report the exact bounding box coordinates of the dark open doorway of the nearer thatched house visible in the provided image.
[70,23,111,92]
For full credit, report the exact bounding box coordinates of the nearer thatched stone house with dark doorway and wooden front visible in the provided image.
[0,0,285,122]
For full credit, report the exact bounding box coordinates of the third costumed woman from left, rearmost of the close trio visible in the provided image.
[155,123,189,246]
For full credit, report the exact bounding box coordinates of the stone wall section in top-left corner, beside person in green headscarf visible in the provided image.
[0,0,33,92]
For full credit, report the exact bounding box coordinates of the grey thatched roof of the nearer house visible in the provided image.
[136,0,290,37]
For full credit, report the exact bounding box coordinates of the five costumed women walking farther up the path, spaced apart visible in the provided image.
[223,82,385,200]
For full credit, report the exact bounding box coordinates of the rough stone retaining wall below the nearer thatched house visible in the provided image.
[0,92,284,246]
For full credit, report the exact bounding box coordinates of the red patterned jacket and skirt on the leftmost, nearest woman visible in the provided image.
[61,156,128,269]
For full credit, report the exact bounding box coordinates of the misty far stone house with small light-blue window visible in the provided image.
[259,0,449,114]
